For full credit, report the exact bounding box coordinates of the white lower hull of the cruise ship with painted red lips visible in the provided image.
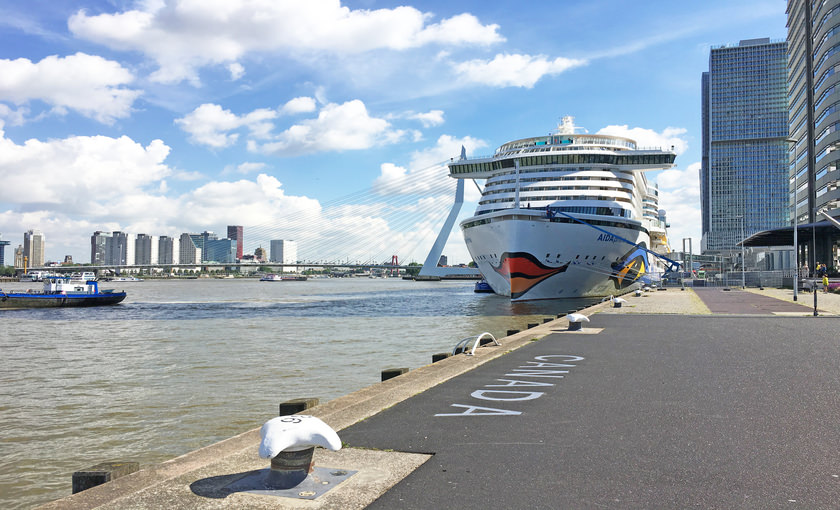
[464,216,650,301]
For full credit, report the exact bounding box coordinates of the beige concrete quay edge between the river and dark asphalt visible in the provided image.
[38,293,624,510]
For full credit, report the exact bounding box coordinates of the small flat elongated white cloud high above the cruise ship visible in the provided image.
[453,54,586,88]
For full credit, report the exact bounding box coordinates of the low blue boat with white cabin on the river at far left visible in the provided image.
[0,276,125,309]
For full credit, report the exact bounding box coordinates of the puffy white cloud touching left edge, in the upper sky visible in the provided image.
[0,53,142,124]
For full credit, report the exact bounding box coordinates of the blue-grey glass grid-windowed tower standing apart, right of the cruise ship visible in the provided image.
[700,39,789,253]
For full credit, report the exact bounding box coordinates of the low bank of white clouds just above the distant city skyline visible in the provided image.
[0,121,470,262]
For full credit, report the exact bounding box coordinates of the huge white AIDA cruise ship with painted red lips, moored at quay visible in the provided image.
[449,117,676,301]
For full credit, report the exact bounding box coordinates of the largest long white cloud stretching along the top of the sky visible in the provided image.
[68,0,504,84]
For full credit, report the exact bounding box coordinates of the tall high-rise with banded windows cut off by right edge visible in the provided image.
[787,0,840,268]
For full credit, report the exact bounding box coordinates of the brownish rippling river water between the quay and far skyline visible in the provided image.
[0,278,585,508]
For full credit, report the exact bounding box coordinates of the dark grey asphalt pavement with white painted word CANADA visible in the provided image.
[340,312,840,509]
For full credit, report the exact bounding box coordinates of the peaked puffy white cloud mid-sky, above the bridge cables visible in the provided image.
[250,99,406,155]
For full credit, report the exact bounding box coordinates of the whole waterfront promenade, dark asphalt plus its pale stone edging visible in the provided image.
[45,288,840,509]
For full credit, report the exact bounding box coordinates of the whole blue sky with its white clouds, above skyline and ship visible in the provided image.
[0,0,786,262]
